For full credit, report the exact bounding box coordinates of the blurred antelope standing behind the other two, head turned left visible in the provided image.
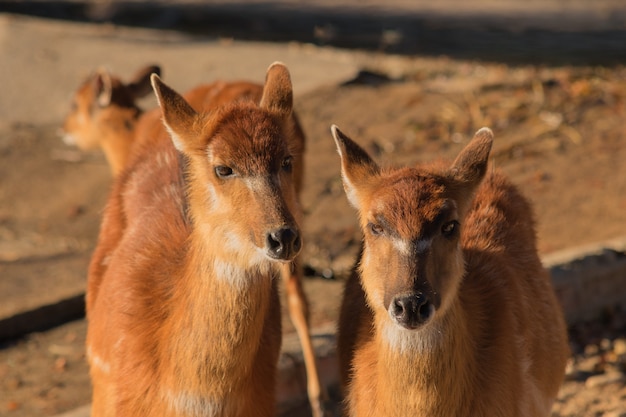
[69,66,326,417]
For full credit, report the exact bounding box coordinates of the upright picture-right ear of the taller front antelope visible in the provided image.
[259,62,293,116]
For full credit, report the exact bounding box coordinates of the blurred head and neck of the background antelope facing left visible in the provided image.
[61,65,160,175]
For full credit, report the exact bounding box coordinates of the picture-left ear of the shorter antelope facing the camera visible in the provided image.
[330,125,380,209]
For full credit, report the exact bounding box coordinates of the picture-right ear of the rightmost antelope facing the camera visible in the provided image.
[450,127,493,192]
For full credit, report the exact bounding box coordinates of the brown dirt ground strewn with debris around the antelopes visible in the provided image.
[0,30,626,417]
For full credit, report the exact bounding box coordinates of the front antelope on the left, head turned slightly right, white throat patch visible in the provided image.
[87,63,302,417]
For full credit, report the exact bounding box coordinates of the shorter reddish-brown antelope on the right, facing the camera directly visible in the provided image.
[332,126,568,417]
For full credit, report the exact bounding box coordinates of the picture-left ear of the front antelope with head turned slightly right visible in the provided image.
[150,74,201,154]
